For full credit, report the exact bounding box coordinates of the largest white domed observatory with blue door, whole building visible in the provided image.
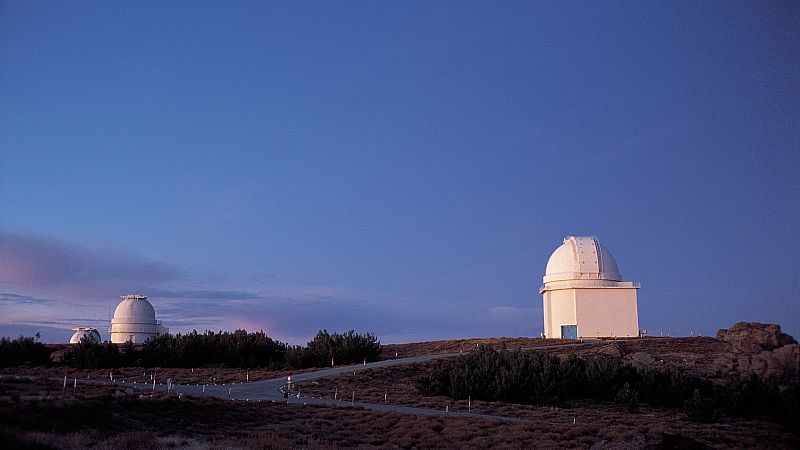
[539,236,640,339]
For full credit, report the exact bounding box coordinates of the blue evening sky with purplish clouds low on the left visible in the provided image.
[0,0,800,344]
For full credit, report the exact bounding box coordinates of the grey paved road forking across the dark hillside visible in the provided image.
[128,341,598,421]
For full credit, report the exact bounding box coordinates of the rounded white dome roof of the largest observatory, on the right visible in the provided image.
[544,236,622,283]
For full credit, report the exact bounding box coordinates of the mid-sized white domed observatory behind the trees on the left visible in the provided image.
[110,295,169,344]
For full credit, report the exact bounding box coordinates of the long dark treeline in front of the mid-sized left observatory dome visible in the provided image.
[63,330,380,370]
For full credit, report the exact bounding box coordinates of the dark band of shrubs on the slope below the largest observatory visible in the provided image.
[417,347,800,425]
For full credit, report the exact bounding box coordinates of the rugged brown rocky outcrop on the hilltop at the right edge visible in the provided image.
[717,322,800,384]
